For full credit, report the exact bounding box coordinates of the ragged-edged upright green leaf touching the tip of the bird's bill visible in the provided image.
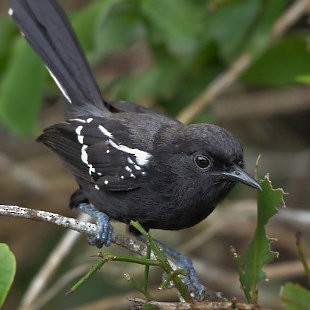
[233,176,284,303]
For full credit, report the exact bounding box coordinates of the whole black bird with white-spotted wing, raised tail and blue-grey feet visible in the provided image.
[9,0,260,293]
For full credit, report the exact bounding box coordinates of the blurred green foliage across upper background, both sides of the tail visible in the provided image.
[0,0,310,135]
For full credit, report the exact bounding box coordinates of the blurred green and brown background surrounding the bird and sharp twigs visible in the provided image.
[0,0,310,309]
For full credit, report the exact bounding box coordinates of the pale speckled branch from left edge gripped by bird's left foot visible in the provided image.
[0,205,146,256]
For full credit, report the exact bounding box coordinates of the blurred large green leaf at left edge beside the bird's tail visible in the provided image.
[0,38,45,136]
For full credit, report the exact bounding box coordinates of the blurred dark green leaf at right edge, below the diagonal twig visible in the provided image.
[242,35,310,87]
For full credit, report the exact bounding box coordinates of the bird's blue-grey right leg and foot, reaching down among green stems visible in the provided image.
[138,235,206,300]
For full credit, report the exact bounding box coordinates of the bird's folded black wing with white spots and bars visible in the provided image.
[38,118,152,191]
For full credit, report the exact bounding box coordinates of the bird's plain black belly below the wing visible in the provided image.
[83,183,215,230]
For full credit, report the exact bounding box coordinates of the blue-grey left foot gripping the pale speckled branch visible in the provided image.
[77,203,113,248]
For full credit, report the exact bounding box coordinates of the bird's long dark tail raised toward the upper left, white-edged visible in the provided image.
[9,0,108,110]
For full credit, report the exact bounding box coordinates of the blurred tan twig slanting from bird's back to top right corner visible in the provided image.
[178,0,310,124]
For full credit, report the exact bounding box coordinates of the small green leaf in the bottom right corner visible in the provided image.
[280,283,310,310]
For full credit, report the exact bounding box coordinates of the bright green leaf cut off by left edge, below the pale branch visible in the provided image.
[0,243,16,308]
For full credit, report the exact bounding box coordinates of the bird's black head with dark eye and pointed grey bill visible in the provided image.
[156,124,261,201]
